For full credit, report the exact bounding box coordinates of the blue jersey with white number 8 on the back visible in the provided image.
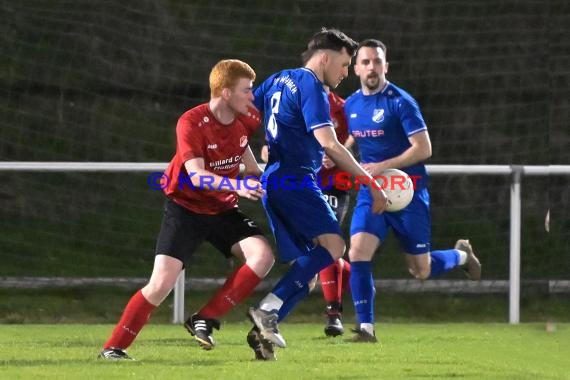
[254,68,332,180]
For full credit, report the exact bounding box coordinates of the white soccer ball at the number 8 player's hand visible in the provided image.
[374,169,414,212]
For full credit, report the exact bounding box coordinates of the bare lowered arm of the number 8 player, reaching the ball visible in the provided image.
[313,127,387,213]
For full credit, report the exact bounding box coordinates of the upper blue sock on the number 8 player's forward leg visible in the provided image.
[271,245,334,306]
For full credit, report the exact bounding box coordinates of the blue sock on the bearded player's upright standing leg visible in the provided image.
[350,261,375,324]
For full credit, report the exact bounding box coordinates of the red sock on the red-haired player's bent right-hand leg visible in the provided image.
[198,264,261,318]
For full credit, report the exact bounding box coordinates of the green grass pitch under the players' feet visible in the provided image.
[0,322,570,380]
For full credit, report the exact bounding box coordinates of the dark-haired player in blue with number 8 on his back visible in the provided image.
[244,28,386,359]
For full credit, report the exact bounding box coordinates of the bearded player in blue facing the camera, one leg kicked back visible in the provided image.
[345,39,481,342]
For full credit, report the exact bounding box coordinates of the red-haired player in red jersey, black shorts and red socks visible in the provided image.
[99,60,275,360]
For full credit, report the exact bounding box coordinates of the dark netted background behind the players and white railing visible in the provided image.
[0,0,570,279]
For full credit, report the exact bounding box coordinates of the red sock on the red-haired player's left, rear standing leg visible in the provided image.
[103,290,156,349]
